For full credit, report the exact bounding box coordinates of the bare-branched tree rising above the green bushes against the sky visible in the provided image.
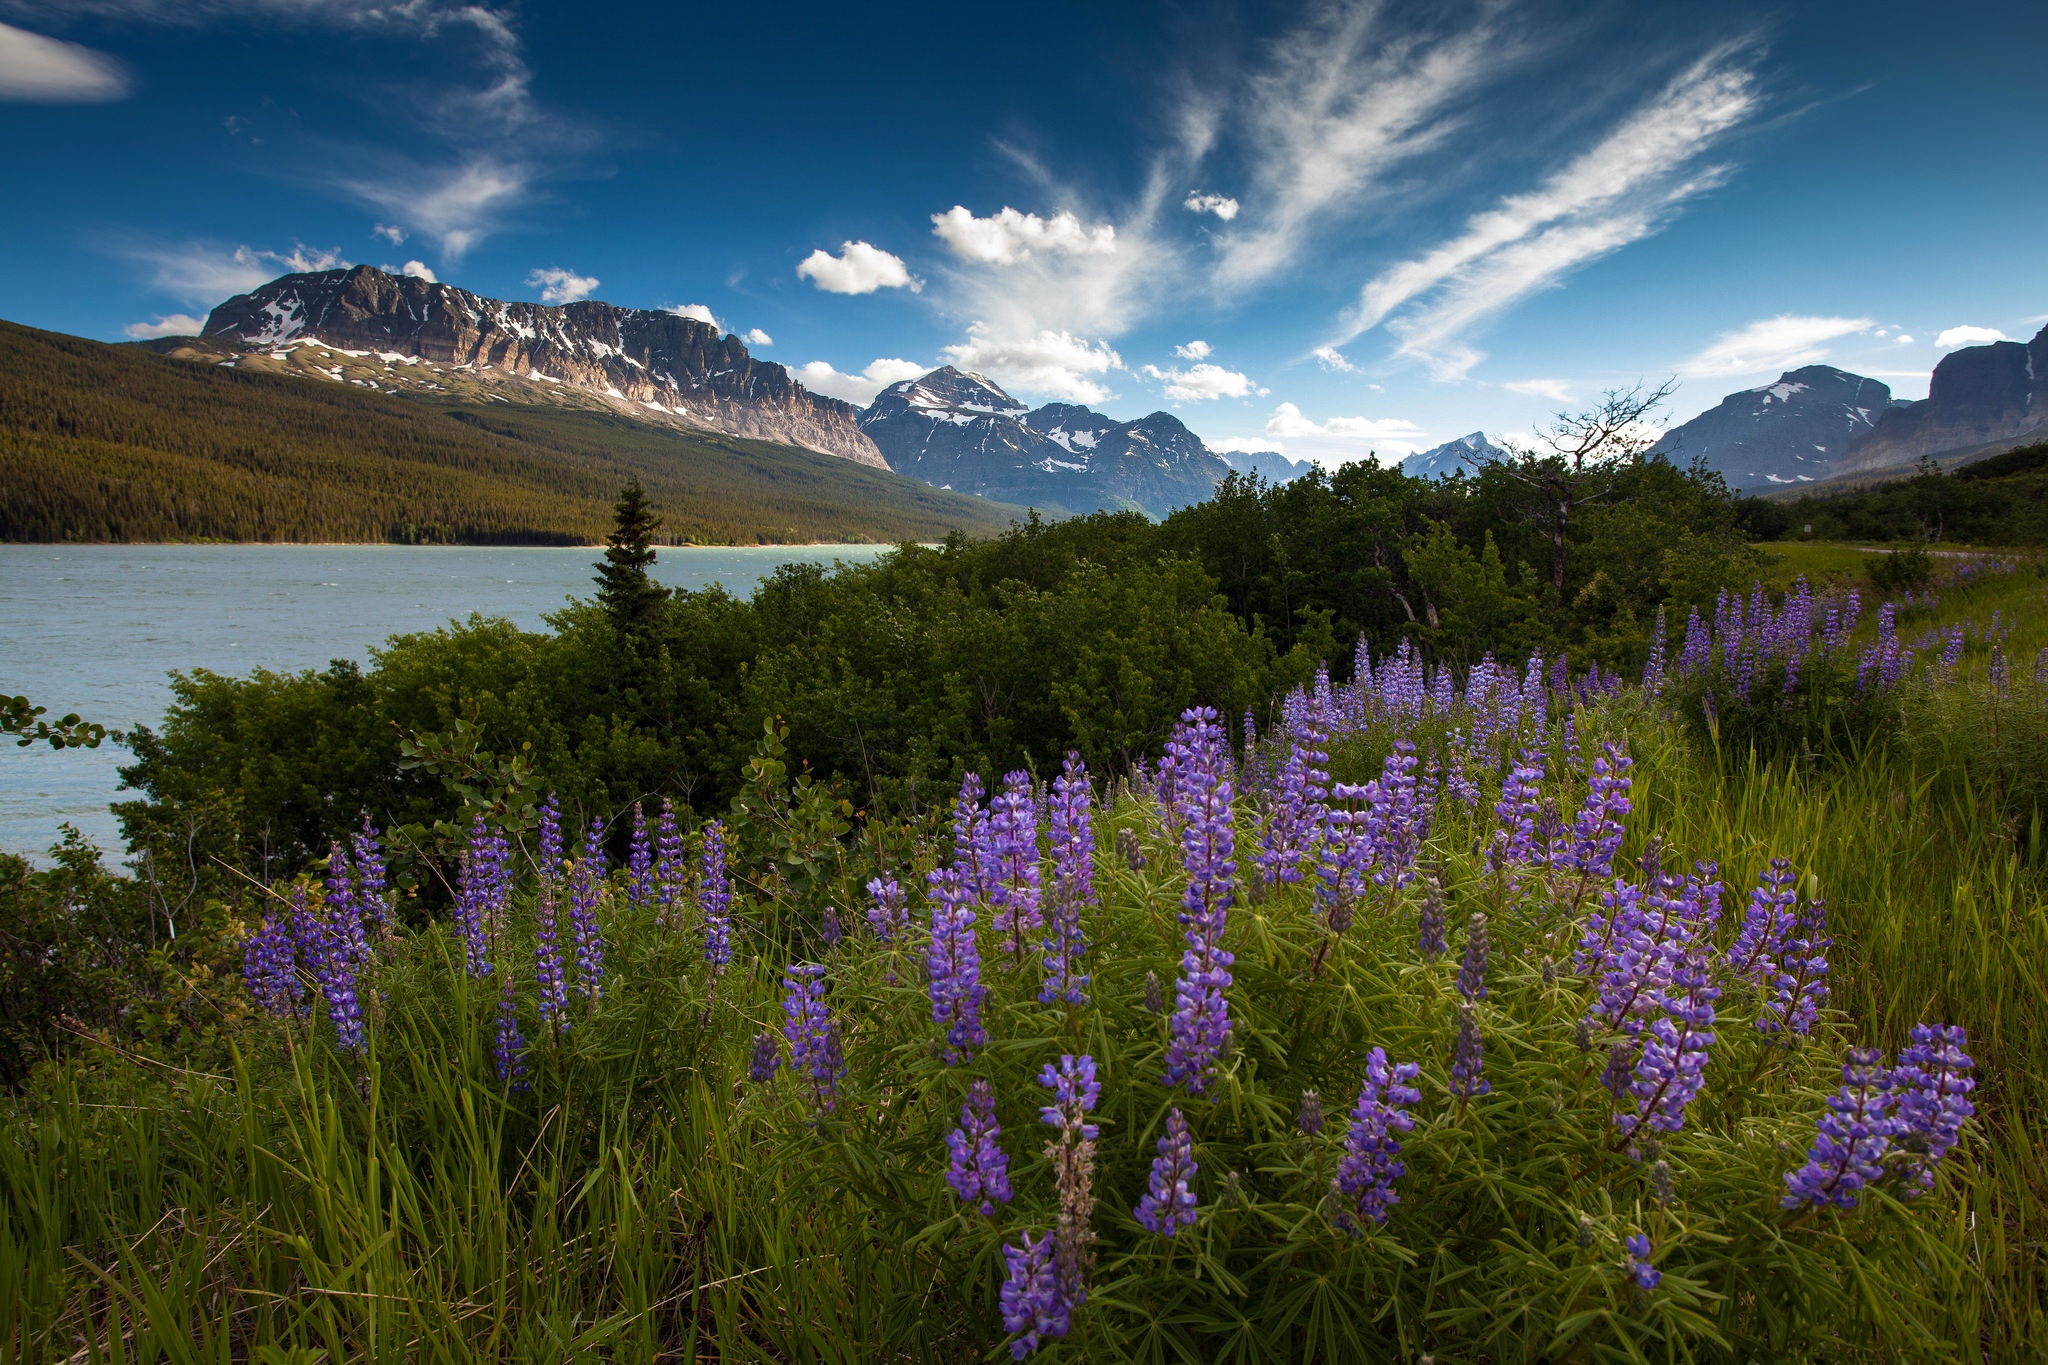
[1487,379,1677,602]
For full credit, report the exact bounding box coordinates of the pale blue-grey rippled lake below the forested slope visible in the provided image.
[0,544,889,855]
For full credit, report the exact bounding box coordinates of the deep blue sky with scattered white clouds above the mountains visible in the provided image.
[0,0,2048,465]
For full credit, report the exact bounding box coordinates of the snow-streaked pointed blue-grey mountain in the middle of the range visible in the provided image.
[860,364,1229,516]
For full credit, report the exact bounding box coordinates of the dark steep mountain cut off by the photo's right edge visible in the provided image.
[1833,327,2048,475]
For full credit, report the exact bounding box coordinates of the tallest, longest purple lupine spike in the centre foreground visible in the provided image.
[1165,706,1237,1093]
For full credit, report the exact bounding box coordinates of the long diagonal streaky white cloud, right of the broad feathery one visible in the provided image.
[1331,43,1763,379]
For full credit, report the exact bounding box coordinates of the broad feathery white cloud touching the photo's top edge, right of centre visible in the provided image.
[1217,4,1520,291]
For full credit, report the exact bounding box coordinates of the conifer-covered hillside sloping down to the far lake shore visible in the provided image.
[0,323,1018,544]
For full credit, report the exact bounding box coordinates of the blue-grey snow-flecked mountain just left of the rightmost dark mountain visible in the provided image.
[1651,364,1892,489]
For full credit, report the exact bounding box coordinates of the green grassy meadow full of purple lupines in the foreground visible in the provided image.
[0,546,2048,1361]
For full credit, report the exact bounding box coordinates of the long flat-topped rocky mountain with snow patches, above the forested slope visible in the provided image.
[201,266,887,469]
